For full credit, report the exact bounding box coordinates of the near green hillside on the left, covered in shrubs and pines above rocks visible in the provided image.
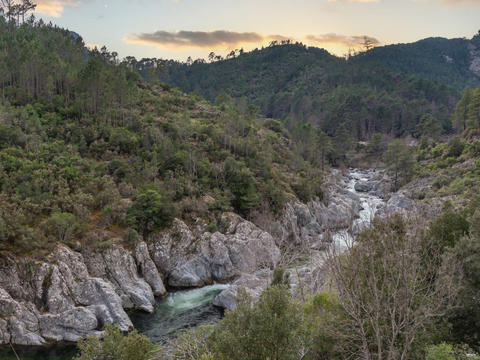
[0,18,321,254]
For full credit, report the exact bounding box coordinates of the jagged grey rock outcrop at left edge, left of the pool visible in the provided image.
[0,246,137,345]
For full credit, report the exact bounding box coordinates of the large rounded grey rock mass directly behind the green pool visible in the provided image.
[148,213,280,288]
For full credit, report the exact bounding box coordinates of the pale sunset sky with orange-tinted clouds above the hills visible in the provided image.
[32,0,480,61]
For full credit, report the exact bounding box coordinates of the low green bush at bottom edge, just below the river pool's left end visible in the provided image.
[75,325,155,360]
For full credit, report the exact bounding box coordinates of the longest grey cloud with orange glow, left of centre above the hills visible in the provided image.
[125,30,268,48]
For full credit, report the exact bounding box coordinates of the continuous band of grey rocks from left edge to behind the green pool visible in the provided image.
[0,213,280,345]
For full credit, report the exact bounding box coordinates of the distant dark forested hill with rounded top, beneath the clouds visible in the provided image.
[153,43,458,140]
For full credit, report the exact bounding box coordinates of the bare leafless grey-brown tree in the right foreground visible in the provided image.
[328,215,461,360]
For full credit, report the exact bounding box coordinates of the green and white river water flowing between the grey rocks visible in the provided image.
[0,169,383,360]
